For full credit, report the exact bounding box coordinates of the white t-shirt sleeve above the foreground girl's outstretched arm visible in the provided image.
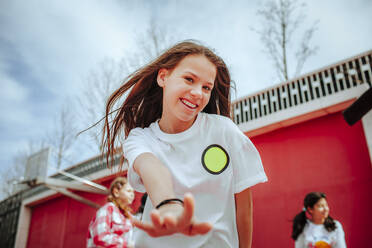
[123,128,152,193]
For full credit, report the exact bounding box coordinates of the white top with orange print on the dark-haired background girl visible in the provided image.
[295,220,346,248]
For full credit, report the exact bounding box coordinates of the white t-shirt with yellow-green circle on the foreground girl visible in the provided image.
[123,113,267,248]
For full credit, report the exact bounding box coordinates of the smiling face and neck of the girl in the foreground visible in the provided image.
[157,55,217,133]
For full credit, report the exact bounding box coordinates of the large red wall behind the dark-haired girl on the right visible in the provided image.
[252,113,372,248]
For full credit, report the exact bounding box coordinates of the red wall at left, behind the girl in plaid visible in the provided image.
[27,176,140,248]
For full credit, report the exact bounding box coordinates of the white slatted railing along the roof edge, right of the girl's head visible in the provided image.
[232,50,372,128]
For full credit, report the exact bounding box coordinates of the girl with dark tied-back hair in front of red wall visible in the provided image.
[292,192,346,248]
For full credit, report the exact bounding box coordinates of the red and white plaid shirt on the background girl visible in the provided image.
[87,202,132,248]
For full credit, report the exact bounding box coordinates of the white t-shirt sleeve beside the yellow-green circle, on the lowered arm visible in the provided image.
[227,120,267,194]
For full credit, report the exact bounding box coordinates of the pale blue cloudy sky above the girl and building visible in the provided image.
[0,0,372,192]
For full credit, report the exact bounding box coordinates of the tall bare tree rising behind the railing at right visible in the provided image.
[251,0,317,81]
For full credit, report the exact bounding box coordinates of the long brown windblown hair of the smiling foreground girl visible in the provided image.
[102,41,233,166]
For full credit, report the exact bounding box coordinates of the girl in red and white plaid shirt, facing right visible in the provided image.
[87,177,134,248]
